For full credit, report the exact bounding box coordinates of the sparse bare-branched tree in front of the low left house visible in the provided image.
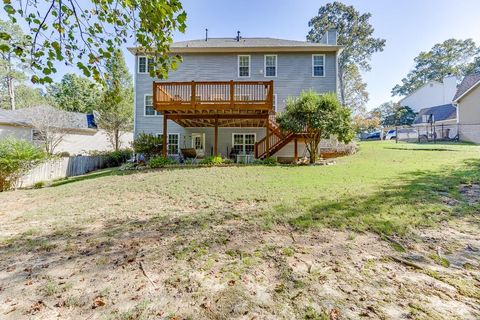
[25,106,75,154]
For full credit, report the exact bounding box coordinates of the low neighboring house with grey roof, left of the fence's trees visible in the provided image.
[0,106,133,155]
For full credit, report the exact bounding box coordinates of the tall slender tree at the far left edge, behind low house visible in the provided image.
[0,20,29,110]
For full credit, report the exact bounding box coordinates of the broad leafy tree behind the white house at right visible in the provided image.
[392,39,480,96]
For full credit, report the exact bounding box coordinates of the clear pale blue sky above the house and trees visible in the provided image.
[126,0,480,109]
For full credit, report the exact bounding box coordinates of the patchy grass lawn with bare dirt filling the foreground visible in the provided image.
[0,142,480,319]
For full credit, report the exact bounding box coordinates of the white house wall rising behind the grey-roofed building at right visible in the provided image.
[398,75,457,112]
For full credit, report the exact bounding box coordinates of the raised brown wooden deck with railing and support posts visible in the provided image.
[153,80,275,156]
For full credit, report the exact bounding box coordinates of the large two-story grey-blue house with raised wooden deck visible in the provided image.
[129,30,341,158]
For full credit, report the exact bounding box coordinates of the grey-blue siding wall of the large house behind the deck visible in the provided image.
[134,52,337,156]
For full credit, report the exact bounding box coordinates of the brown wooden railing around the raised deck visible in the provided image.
[153,81,273,111]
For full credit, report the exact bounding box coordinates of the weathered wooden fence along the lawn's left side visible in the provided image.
[16,156,105,188]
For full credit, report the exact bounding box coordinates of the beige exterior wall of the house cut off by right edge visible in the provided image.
[457,85,480,143]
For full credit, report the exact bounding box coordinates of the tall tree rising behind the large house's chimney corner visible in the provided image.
[307,1,385,105]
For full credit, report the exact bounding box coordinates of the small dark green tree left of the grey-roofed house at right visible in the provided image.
[372,101,416,127]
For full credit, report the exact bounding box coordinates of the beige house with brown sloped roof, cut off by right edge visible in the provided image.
[453,71,480,143]
